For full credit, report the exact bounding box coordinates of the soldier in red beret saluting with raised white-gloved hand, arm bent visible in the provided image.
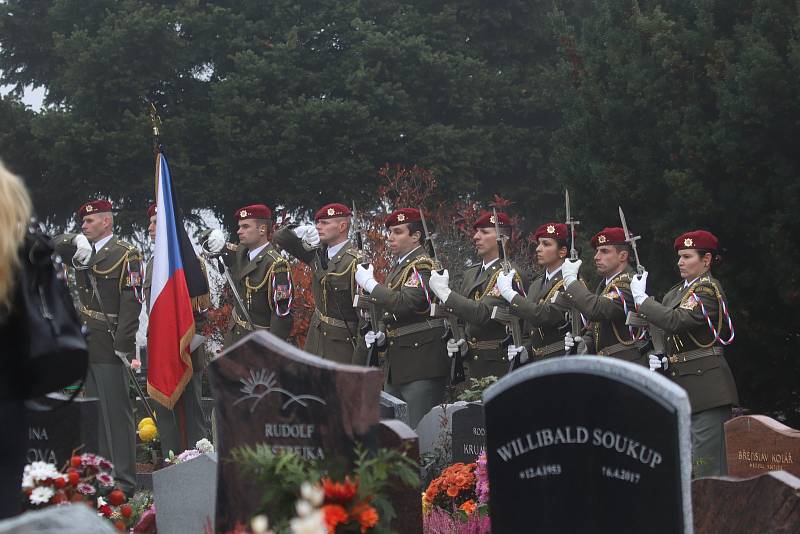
[274,204,366,365]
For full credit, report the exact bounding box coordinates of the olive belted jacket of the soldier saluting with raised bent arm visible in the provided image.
[274,228,367,365]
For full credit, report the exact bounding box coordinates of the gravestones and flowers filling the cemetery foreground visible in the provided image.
[9,333,800,534]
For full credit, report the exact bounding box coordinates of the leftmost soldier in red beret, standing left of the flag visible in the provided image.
[55,200,142,495]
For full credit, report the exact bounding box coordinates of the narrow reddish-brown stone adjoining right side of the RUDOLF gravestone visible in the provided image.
[378,419,422,534]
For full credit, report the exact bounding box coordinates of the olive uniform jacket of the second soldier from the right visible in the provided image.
[557,265,648,366]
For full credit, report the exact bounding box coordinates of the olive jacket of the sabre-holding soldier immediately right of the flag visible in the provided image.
[217,243,292,348]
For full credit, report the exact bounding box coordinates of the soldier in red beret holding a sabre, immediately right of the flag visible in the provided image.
[206,204,292,347]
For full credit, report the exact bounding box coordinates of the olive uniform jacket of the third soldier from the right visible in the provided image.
[511,271,569,361]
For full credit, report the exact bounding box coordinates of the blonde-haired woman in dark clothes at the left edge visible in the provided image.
[0,162,31,519]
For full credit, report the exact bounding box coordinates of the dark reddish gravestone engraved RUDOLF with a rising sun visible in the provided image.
[208,332,383,532]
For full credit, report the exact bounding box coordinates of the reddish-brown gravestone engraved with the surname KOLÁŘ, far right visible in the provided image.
[725,415,800,477]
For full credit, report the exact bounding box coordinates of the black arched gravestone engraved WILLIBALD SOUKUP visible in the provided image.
[483,356,692,534]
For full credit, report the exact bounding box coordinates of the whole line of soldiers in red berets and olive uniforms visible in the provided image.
[55,189,738,494]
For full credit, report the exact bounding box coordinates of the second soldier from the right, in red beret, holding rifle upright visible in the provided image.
[556,227,647,365]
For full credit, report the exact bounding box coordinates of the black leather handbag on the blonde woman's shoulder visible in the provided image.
[0,222,89,399]
